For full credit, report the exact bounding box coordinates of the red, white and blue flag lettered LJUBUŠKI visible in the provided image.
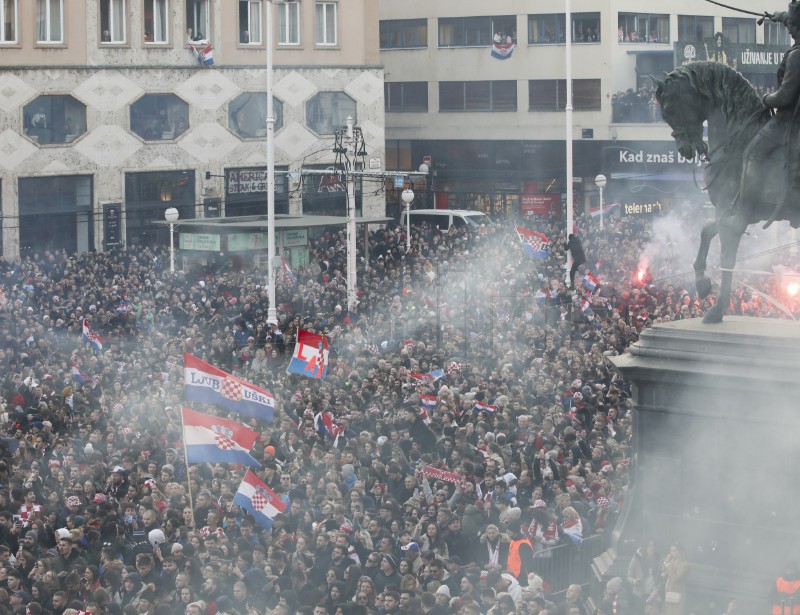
[183,353,275,421]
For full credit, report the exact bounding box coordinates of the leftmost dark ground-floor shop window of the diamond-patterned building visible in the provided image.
[18,175,94,254]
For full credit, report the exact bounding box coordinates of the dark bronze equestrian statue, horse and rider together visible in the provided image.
[655,0,800,323]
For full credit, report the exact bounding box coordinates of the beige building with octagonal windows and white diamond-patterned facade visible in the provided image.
[0,0,385,257]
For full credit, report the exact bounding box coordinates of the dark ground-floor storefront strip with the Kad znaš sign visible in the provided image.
[387,138,704,220]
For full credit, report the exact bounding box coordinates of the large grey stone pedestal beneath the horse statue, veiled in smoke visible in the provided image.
[613,316,800,613]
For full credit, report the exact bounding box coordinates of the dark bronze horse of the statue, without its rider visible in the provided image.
[654,62,800,323]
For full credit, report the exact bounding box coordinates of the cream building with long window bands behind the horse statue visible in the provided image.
[380,0,791,216]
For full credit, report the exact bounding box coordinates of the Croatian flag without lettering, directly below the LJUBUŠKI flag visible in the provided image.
[181,408,261,468]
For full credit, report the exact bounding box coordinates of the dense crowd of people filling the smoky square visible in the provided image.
[0,205,792,615]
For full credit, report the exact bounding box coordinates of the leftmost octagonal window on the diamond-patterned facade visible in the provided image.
[22,96,86,145]
